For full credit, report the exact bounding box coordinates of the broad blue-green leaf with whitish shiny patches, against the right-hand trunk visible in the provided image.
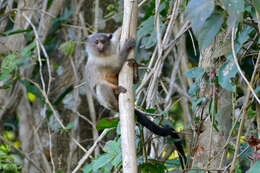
[218,60,237,91]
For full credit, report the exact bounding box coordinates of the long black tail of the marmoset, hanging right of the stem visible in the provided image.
[135,109,187,169]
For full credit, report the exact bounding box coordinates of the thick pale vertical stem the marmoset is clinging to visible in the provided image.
[118,0,137,173]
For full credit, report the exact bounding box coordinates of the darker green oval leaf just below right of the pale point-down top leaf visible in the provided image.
[199,13,224,49]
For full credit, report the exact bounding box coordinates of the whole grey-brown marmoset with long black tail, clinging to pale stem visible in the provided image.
[85,29,186,168]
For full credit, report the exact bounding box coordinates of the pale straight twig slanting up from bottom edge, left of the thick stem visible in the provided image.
[72,129,111,173]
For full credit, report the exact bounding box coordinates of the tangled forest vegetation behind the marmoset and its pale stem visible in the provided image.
[0,0,260,173]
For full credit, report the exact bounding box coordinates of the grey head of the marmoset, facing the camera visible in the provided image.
[86,33,112,57]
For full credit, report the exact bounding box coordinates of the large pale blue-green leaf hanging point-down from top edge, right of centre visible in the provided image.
[185,0,215,35]
